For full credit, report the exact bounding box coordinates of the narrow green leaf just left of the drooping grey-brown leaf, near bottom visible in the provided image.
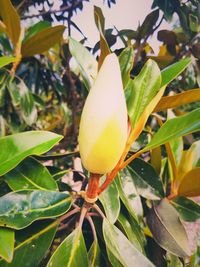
[118,213,145,254]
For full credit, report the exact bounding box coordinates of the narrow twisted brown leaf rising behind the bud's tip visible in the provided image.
[94,6,110,69]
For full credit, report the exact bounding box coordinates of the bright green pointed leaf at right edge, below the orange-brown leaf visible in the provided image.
[142,109,200,151]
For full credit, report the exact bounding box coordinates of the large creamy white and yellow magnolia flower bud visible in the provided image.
[79,54,127,174]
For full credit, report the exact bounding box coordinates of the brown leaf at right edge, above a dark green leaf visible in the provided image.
[178,167,200,197]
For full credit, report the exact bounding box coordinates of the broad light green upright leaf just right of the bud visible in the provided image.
[127,59,161,127]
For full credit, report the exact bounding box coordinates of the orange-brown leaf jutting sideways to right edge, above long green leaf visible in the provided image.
[154,88,200,112]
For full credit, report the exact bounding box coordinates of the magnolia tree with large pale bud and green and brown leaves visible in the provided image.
[0,0,200,267]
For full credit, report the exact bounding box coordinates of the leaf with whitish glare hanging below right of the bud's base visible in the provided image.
[115,172,143,220]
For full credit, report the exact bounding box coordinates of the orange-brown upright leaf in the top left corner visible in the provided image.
[0,0,21,46]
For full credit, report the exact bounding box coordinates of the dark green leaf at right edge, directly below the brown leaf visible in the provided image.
[171,197,200,222]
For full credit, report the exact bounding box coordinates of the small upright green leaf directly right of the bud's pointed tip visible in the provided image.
[119,46,134,89]
